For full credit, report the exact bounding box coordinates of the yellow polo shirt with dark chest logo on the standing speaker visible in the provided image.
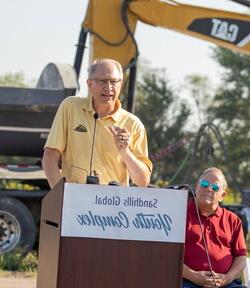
[45,96,152,185]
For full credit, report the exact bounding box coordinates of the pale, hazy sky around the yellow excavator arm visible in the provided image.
[0,0,246,93]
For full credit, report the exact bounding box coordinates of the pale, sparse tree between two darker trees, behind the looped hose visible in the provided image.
[177,74,221,185]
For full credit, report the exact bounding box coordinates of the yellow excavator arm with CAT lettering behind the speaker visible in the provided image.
[74,0,250,111]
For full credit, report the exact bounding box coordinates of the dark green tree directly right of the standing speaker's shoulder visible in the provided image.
[135,67,190,183]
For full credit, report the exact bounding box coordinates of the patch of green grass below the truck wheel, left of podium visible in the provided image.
[0,249,38,272]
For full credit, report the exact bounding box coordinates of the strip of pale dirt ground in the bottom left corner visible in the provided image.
[0,272,36,288]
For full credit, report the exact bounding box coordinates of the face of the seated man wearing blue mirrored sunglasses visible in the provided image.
[196,171,226,207]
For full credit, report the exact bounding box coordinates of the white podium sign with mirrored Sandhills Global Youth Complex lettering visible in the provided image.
[61,183,187,243]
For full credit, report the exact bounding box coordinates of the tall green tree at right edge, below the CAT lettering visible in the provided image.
[210,48,250,200]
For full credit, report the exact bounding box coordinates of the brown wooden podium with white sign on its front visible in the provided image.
[37,180,187,288]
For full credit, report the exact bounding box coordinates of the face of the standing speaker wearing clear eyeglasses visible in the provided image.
[87,62,122,108]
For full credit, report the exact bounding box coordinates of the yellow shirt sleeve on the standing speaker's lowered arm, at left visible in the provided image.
[44,99,69,153]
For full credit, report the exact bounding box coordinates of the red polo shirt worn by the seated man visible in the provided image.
[184,200,247,274]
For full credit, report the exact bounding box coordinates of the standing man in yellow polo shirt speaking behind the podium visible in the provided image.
[42,59,152,188]
